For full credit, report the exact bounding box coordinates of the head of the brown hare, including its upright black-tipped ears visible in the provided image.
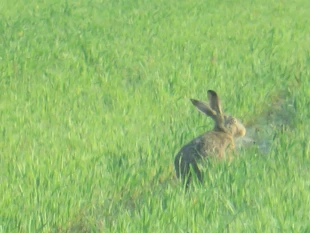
[191,90,246,137]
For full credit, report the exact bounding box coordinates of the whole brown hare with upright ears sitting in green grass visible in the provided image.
[174,90,246,187]
